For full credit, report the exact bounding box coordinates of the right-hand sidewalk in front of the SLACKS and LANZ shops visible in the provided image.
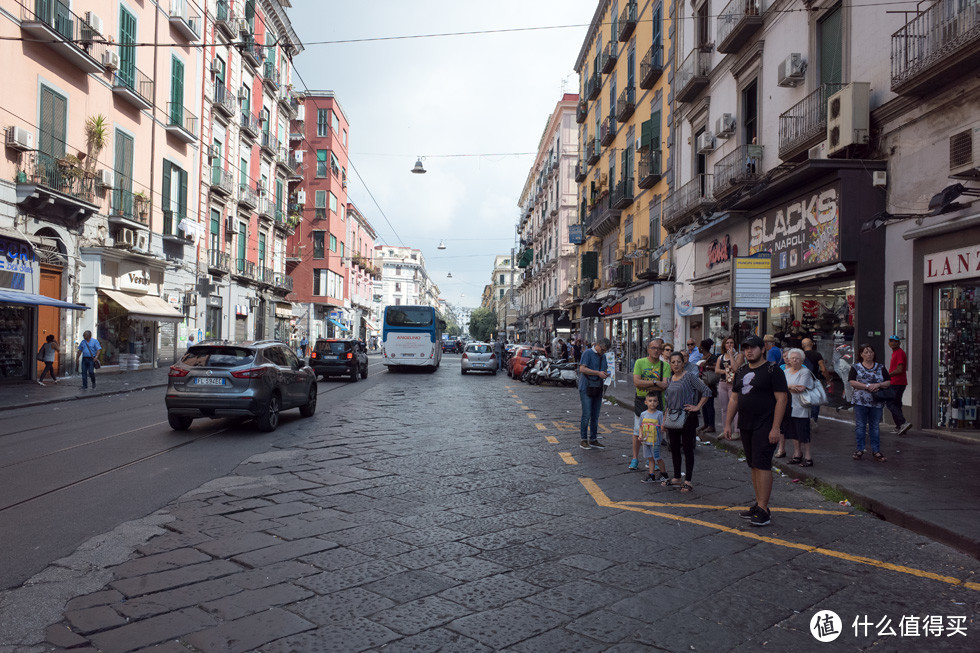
[606,374,980,559]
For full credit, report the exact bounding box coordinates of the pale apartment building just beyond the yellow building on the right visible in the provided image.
[512,93,581,341]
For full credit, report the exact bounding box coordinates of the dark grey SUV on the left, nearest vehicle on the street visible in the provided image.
[167,340,317,431]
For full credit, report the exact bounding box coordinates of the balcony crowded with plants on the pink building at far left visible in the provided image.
[16,150,99,219]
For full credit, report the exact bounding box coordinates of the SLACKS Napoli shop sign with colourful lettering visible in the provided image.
[749,184,840,274]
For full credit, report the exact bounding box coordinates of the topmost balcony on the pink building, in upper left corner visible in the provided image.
[20,0,106,73]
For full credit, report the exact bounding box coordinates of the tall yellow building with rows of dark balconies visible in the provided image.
[575,0,673,369]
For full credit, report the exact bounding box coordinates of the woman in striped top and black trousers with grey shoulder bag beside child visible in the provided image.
[662,351,711,492]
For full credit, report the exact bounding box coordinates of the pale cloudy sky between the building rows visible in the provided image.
[287,0,598,308]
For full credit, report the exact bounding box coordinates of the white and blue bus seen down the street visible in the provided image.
[381,306,446,372]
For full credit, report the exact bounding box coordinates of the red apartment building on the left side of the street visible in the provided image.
[287,91,352,339]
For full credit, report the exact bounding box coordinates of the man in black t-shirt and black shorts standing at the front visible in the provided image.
[725,336,789,526]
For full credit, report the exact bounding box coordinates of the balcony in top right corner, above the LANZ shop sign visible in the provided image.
[892,0,980,95]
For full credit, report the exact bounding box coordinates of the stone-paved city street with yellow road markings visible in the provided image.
[0,355,980,653]
